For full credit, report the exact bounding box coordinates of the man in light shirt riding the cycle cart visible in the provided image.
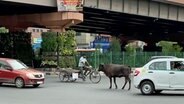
[78,55,90,81]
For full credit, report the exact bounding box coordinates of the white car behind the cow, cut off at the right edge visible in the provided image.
[134,57,184,95]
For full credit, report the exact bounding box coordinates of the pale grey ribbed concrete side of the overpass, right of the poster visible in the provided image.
[85,0,184,21]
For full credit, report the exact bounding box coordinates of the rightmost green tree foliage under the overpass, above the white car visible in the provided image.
[158,41,183,53]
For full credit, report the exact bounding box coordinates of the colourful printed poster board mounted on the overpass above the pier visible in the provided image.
[57,0,84,12]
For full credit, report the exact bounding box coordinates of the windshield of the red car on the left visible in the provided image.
[8,60,28,70]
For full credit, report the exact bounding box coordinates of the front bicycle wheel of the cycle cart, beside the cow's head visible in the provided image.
[89,71,101,83]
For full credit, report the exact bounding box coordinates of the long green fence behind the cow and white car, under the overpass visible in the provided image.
[76,52,184,68]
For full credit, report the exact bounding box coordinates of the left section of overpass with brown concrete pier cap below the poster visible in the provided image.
[0,0,83,32]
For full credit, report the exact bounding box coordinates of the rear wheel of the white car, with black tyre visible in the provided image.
[140,81,154,95]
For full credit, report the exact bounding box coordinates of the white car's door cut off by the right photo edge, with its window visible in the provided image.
[169,61,184,89]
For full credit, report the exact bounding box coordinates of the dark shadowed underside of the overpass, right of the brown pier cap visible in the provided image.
[71,7,184,42]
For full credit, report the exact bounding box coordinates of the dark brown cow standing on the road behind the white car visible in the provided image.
[99,64,131,90]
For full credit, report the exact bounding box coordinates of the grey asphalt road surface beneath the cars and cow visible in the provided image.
[0,76,184,104]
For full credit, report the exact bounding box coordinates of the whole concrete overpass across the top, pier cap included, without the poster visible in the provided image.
[0,0,184,50]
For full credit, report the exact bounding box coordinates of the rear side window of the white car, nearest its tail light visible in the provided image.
[149,61,167,70]
